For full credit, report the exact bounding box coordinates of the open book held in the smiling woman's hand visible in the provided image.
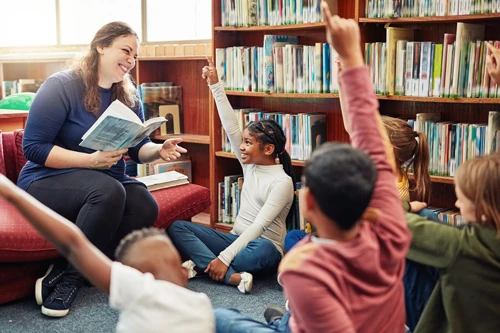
[80,100,167,151]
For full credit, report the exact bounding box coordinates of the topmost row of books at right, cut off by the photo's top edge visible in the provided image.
[365,0,500,18]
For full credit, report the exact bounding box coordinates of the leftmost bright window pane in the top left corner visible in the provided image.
[0,0,57,46]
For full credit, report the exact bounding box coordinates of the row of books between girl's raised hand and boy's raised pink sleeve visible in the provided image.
[215,35,338,94]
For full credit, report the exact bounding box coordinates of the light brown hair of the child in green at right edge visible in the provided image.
[455,153,500,237]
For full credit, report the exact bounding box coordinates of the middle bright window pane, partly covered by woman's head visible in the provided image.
[59,0,142,44]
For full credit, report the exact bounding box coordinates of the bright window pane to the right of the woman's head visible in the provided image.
[146,0,212,42]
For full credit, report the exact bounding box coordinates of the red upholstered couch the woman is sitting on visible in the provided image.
[0,130,210,304]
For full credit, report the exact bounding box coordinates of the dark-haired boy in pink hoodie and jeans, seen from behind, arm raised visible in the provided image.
[215,2,411,333]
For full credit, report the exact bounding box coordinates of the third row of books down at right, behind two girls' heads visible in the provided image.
[408,111,500,176]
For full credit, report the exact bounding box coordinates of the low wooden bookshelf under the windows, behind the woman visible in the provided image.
[0,52,210,191]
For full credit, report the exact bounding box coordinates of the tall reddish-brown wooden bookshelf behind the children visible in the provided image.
[209,0,500,231]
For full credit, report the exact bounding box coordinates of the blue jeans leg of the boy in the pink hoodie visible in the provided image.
[214,309,291,333]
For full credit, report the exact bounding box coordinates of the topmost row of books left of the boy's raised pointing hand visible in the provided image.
[221,0,337,27]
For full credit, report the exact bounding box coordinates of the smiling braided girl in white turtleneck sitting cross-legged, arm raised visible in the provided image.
[167,59,295,293]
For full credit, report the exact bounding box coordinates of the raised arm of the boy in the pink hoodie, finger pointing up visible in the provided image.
[322,2,409,243]
